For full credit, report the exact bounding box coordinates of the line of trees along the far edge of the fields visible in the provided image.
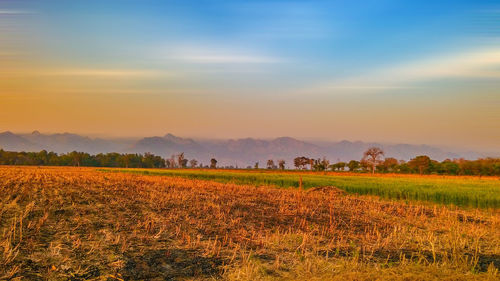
[0,147,500,176]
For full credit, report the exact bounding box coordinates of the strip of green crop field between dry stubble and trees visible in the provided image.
[101,169,500,208]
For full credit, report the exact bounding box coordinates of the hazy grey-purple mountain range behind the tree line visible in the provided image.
[0,131,490,167]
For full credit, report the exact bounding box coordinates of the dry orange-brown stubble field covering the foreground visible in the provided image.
[0,167,500,280]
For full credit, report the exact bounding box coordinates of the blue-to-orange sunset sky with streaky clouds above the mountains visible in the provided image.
[0,0,500,152]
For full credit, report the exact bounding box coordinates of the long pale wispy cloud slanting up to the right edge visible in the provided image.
[310,49,500,92]
